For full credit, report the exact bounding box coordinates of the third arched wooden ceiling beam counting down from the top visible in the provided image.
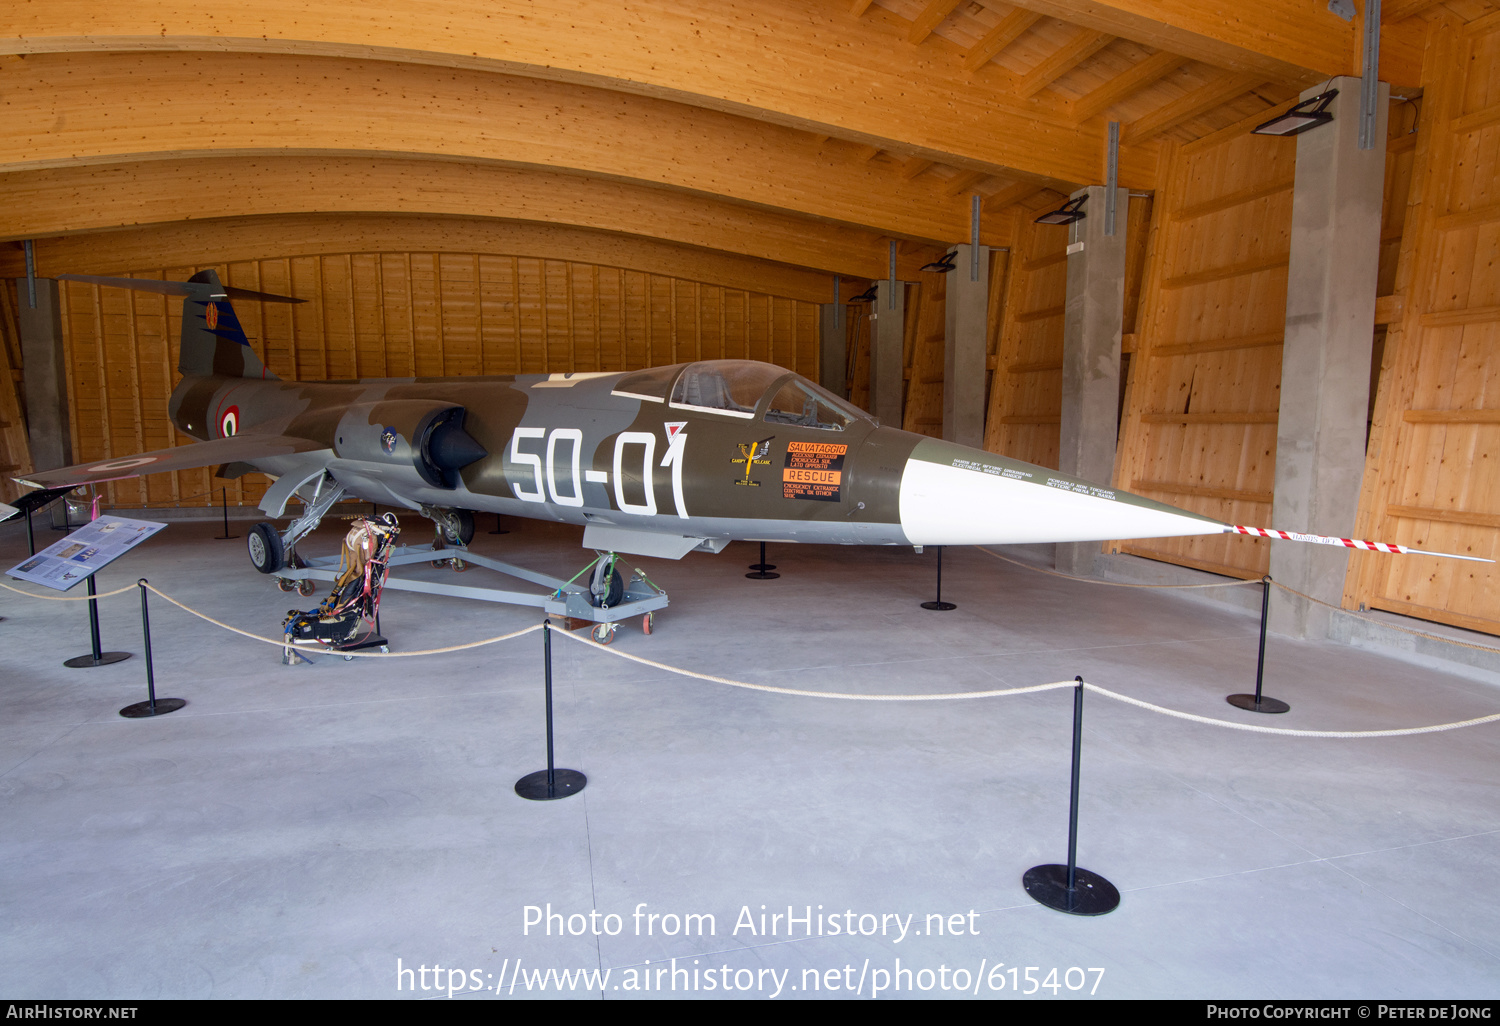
[0,156,936,278]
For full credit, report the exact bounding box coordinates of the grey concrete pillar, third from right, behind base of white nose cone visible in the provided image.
[942,245,990,449]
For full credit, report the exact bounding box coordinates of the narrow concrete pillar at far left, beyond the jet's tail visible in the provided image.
[15,278,74,471]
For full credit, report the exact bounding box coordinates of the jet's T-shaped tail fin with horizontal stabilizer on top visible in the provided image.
[57,269,303,380]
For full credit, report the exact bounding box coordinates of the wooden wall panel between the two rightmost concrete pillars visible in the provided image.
[1110,119,1296,578]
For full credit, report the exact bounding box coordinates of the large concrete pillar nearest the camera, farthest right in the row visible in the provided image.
[1266,78,1389,638]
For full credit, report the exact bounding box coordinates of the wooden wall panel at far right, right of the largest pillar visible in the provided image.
[1344,12,1500,633]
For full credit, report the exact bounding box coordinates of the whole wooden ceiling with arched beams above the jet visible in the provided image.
[0,0,1452,288]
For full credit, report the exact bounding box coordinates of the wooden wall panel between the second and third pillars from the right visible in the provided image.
[984,207,1068,468]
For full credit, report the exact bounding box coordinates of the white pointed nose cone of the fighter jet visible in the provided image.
[900,440,1226,545]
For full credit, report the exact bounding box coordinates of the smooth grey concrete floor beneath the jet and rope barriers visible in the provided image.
[0,518,1500,1001]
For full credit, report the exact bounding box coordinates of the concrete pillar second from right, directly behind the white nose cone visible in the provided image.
[1058,186,1130,576]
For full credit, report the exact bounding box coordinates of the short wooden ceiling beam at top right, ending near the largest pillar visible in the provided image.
[990,0,1422,86]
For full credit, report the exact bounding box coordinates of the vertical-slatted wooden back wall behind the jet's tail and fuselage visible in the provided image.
[55,252,818,507]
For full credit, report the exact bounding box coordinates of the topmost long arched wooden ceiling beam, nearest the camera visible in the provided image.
[0,0,1157,188]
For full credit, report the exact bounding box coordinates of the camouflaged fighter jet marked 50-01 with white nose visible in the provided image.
[24,270,1472,597]
